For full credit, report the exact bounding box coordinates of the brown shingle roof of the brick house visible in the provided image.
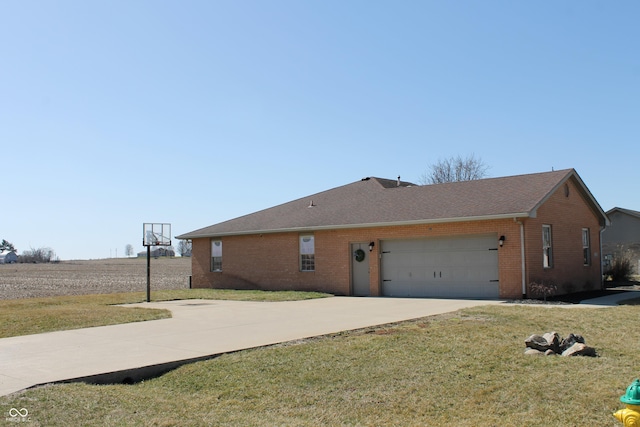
[177,169,607,239]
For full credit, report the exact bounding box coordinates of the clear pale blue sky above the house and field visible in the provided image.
[0,0,640,260]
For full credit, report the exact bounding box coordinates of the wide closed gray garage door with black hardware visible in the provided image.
[381,234,500,298]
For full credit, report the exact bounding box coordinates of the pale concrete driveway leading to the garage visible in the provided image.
[0,297,500,396]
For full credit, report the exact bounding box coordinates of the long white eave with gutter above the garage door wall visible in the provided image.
[176,212,535,240]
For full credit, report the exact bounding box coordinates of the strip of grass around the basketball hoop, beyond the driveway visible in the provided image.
[0,289,327,338]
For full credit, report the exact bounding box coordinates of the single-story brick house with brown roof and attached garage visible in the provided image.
[177,169,608,299]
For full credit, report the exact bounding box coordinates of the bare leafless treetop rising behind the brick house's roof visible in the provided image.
[418,154,489,184]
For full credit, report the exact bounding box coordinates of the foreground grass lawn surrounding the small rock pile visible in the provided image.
[0,305,640,427]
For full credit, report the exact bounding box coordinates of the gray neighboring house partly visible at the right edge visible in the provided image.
[602,208,640,273]
